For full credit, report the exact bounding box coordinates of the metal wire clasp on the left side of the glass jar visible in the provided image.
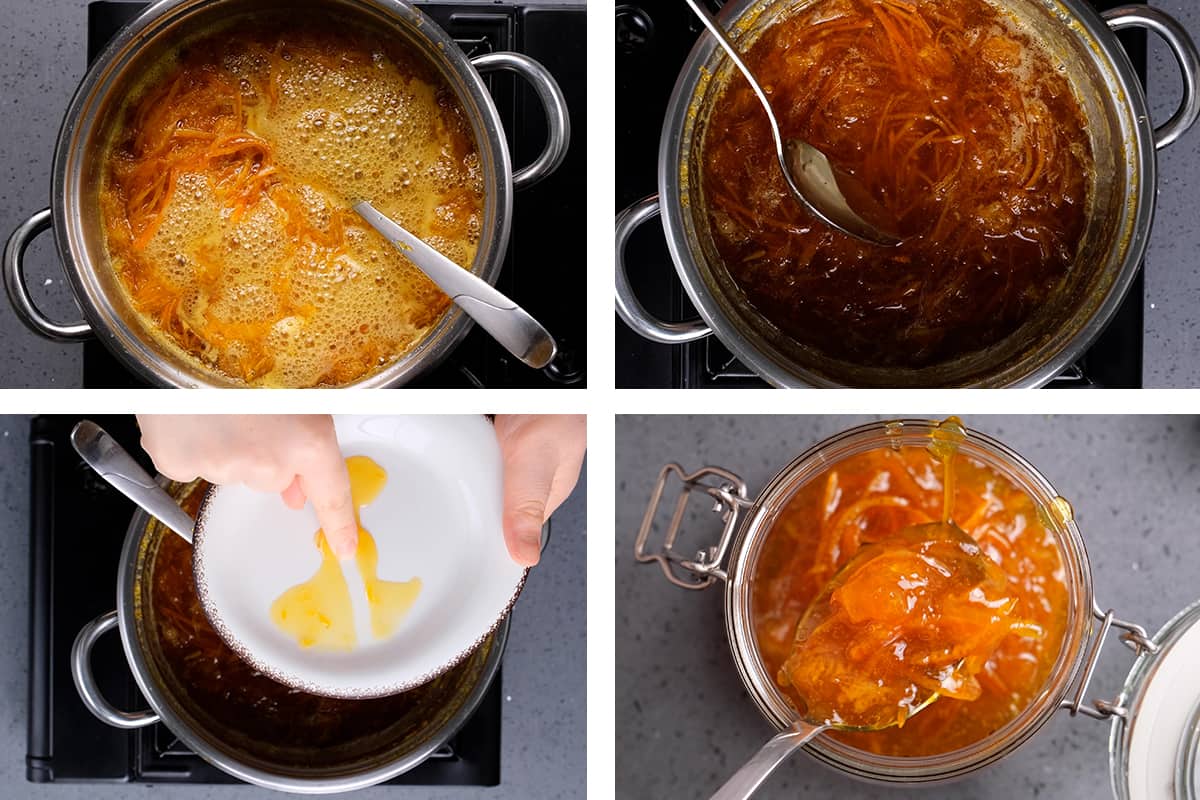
[634,463,754,589]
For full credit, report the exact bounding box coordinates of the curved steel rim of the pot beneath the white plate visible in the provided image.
[116,489,511,794]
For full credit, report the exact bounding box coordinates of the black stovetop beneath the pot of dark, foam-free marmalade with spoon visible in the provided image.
[616,0,1146,389]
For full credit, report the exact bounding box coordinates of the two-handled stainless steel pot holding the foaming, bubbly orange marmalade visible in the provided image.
[4,0,570,386]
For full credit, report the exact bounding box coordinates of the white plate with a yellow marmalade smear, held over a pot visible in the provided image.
[193,416,527,698]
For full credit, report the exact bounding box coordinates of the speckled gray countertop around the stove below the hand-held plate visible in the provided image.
[0,416,587,800]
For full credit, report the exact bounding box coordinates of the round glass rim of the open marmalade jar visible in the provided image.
[724,419,1094,786]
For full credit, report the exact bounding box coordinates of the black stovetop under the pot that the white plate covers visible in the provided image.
[28,416,502,796]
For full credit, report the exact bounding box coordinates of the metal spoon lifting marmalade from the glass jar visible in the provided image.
[712,522,988,800]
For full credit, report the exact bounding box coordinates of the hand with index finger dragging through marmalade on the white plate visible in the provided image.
[138,414,359,558]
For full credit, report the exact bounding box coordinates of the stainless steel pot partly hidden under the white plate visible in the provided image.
[71,485,509,794]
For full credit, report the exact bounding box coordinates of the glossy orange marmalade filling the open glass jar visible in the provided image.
[751,434,1068,756]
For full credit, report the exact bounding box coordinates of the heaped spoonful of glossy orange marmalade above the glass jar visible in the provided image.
[779,523,1030,729]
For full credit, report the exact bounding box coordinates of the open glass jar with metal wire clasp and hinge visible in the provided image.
[635,420,1171,796]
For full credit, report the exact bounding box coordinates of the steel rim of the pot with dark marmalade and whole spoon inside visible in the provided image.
[659,0,1158,387]
